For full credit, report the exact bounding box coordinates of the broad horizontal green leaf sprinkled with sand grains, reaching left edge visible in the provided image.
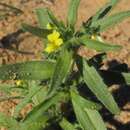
[0,60,55,80]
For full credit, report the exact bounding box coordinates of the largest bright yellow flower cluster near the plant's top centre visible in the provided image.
[45,30,63,53]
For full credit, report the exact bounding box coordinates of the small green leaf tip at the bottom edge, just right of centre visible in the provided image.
[60,118,76,130]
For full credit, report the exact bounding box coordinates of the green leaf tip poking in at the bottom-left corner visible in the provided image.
[0,113,18,128]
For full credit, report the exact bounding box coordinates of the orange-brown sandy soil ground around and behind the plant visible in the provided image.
[0,0,130,130]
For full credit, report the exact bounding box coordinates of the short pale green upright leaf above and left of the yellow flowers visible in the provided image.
[36,8,52,28]
